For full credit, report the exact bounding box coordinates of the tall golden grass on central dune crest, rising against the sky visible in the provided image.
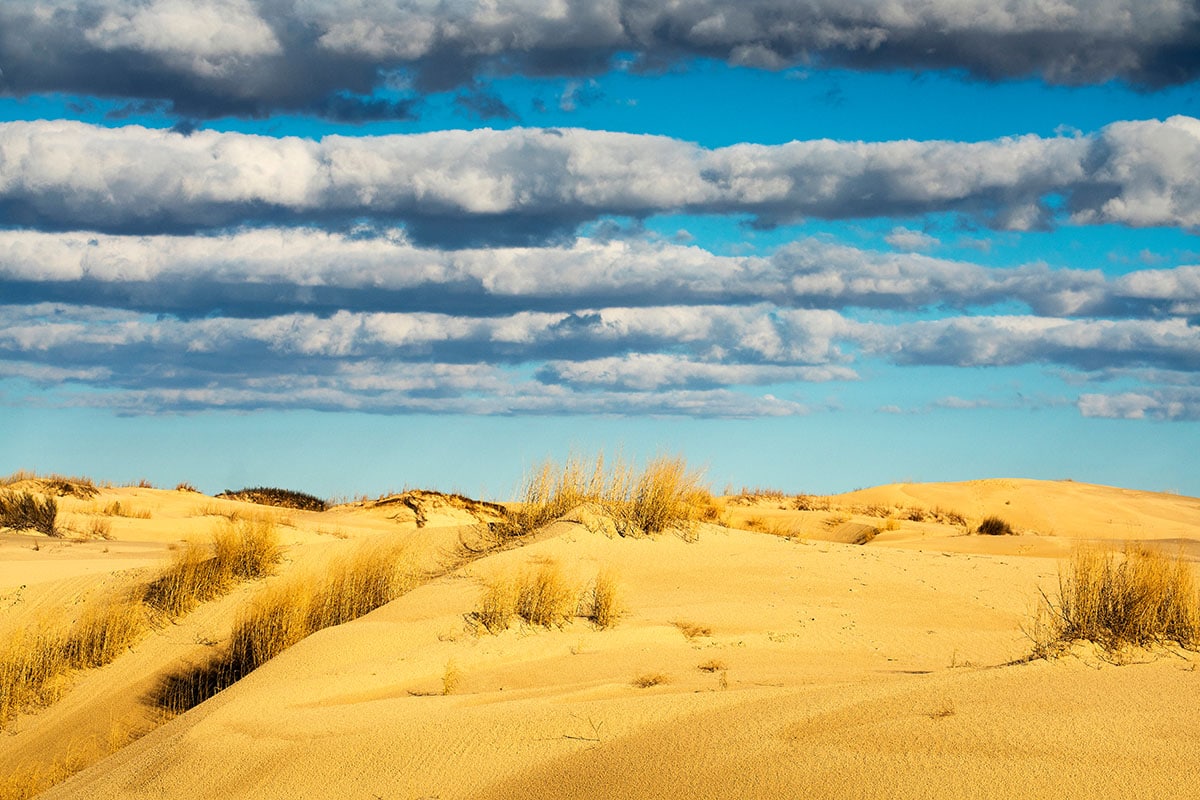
[496,455,720,537]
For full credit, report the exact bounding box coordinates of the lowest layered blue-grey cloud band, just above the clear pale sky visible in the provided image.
[0,297,1200,419]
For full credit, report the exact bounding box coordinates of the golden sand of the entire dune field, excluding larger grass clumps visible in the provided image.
[0,480,1200,800]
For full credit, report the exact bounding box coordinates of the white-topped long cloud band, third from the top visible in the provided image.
[9,228,1200,318]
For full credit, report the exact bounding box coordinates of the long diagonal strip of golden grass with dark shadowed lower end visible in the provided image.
[155,542,415,714]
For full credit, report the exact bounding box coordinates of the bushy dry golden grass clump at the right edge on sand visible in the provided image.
[1031,547,1200,657]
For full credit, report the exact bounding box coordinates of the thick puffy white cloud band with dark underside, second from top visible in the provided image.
[0,116,1200,241]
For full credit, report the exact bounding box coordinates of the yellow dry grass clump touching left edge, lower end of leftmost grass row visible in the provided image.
[0,599,146,728]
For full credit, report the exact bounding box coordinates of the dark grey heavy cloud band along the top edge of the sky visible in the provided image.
[0,0,1200,116]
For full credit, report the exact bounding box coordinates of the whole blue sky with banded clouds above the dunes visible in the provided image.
[0,0,1200,499]
